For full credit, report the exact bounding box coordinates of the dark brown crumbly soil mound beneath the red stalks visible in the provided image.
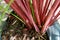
[2,13,49,40]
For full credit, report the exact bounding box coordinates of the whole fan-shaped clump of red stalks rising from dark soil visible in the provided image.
[5,0,60,34]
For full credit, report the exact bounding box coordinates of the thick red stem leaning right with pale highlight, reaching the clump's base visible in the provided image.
[41,0,60,33]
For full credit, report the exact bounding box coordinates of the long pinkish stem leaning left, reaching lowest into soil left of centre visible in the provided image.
[16,0,40,32]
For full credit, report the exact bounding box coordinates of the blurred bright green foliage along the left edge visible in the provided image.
[0,0,13,33]
